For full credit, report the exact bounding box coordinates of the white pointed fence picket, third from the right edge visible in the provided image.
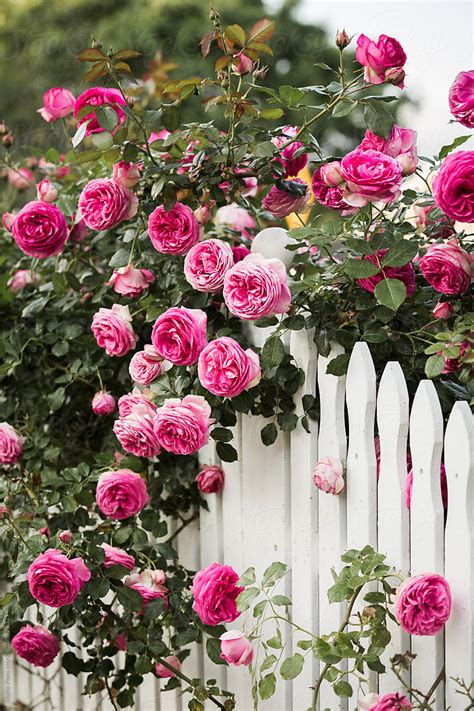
[377,362,410,694]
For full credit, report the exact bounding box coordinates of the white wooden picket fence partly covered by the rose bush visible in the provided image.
[3,329,474,711]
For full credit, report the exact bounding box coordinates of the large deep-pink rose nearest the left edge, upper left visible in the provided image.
[12,200,68,259]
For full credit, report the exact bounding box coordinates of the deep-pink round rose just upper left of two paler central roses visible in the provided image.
[148,202,199,255]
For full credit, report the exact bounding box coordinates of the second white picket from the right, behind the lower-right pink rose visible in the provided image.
[410,380,445,711]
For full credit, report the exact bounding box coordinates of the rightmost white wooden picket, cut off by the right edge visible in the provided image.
[445,402,474,709]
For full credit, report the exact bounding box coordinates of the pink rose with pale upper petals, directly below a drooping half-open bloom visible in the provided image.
[91,304,137,356]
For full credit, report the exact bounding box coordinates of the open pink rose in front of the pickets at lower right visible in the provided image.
[394,573,451,636]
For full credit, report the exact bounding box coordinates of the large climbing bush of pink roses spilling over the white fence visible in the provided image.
[0,11,474,711]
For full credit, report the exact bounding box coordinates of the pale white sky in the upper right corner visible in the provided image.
[266,0,474,156]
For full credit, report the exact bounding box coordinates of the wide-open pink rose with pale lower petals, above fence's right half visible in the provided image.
[341,148,402,207]
